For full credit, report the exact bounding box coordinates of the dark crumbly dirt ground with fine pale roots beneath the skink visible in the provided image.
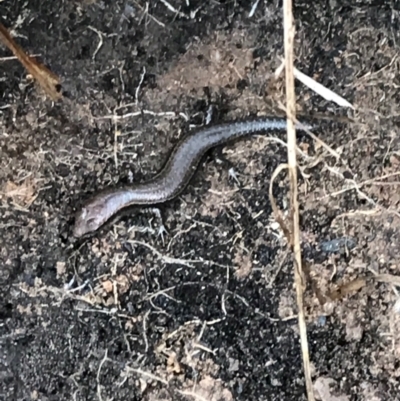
[0,0,400,401]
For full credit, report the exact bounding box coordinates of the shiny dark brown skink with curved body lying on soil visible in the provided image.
[73,117,311,237]
